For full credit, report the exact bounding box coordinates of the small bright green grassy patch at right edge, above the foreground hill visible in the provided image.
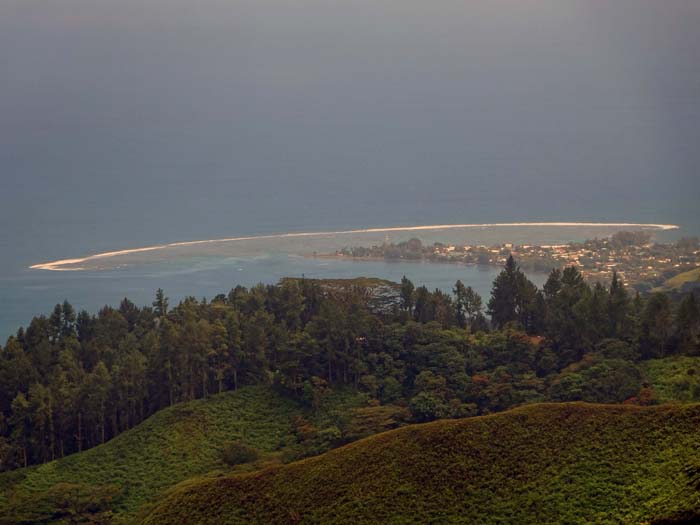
[639,356,700,403]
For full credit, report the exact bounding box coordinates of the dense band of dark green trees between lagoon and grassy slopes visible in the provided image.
[0,257,700,470]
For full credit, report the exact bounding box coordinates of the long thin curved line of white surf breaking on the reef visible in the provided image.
[29,222,678,271]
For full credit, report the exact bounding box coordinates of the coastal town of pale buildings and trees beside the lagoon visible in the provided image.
[327,231,700,292]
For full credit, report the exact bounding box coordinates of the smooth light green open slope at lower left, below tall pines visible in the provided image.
[0,387,301,522]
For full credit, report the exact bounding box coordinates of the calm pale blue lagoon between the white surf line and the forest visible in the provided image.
[0,224,677,336]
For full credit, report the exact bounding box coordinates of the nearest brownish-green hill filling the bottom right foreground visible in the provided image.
[144,403,700,524]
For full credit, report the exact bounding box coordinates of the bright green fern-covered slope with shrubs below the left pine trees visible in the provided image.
[0,386,376,524]
